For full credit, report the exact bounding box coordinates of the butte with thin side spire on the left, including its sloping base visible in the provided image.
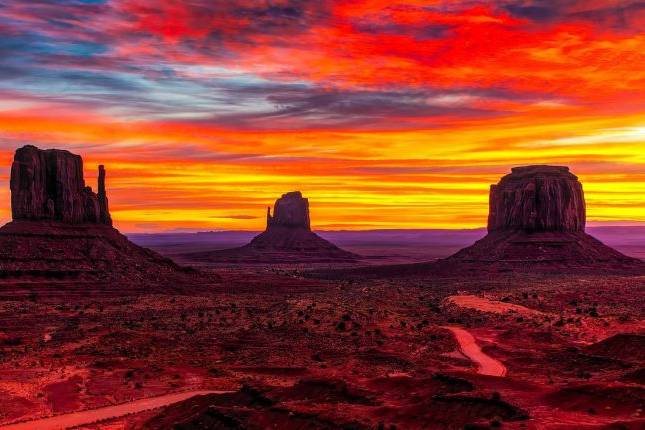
[0,145,208,296]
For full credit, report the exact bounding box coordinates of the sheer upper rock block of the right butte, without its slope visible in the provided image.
[488,166,586,233]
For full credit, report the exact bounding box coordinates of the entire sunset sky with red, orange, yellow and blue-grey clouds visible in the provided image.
[0,0,645,232]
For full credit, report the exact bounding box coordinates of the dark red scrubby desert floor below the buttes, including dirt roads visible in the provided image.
[0,242,645,429]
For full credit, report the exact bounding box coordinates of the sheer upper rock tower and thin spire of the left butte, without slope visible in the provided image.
[11,145,112,225]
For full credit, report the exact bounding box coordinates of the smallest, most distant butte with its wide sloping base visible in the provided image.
[182,191,361,264]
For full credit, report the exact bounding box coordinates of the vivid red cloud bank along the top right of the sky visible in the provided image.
[100,0,645,105]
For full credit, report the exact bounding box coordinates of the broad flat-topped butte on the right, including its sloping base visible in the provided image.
[440,165,643,272]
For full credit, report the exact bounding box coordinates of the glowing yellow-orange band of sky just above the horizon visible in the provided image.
[0,111,645,232]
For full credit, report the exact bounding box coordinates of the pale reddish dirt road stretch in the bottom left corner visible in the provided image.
[0,390,231,430]
